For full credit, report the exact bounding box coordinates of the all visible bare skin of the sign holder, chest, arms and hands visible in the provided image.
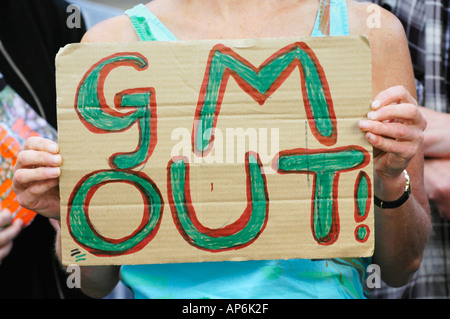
[14,0,430,297]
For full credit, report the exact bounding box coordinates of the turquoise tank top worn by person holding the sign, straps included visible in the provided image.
[121,0,371,299]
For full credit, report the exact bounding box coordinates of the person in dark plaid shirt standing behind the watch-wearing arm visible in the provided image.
[366,0,450,299]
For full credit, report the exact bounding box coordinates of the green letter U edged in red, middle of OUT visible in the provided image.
[167,152,269,252]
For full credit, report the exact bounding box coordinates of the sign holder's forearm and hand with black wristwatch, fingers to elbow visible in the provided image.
[366,87,431,286]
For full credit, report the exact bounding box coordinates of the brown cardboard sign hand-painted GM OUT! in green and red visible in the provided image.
[56,37,374,265]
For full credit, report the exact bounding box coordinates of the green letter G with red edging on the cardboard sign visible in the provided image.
[75,53,156,170]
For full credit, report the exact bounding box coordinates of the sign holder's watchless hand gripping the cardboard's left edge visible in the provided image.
[13,137,62,220]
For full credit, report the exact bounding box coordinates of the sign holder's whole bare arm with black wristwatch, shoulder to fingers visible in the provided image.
[352,3,431,286]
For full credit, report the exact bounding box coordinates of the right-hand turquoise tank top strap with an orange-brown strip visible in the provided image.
[311,0,350,37]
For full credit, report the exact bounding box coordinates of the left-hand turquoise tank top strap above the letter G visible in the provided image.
[125,4,177,41]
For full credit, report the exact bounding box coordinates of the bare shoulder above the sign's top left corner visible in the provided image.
[81,15,139,43]
